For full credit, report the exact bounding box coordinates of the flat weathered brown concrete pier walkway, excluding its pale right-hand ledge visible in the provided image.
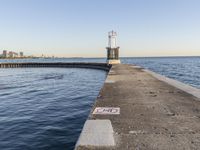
[75,64,200,150]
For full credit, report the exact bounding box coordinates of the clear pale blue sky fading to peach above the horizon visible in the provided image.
[0,0,200,57]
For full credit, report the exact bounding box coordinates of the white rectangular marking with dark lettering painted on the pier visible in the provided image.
[93,107,120,115]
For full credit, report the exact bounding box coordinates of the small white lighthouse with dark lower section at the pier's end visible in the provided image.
[106,31,120,64]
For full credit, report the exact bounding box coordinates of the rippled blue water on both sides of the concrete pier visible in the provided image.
[0,57,200,150]
